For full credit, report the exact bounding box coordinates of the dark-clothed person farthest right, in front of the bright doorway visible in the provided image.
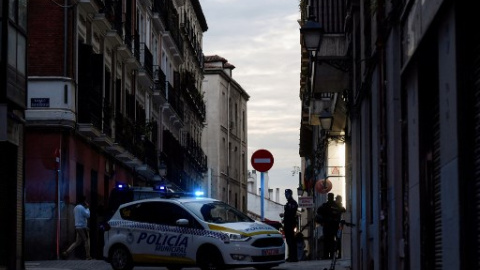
[317,193,345,259]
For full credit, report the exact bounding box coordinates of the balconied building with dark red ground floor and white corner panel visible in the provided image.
[25,0,208,260]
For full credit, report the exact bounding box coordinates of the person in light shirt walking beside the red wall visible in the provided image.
[62,196,92,260]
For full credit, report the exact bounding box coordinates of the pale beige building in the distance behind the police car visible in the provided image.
[202,55,250,213]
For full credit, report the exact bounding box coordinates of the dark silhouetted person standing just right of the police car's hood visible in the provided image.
[280,189,298,262]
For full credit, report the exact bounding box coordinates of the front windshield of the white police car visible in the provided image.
[184,201,254,223]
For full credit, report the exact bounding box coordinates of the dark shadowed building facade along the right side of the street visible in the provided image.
[300,0,480,269]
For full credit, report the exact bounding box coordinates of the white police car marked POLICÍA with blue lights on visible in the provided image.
[103,195,285,270]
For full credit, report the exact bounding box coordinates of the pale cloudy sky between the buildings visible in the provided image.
[200,0,301,203]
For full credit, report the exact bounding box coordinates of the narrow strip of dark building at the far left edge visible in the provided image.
[0,0,27,269]
